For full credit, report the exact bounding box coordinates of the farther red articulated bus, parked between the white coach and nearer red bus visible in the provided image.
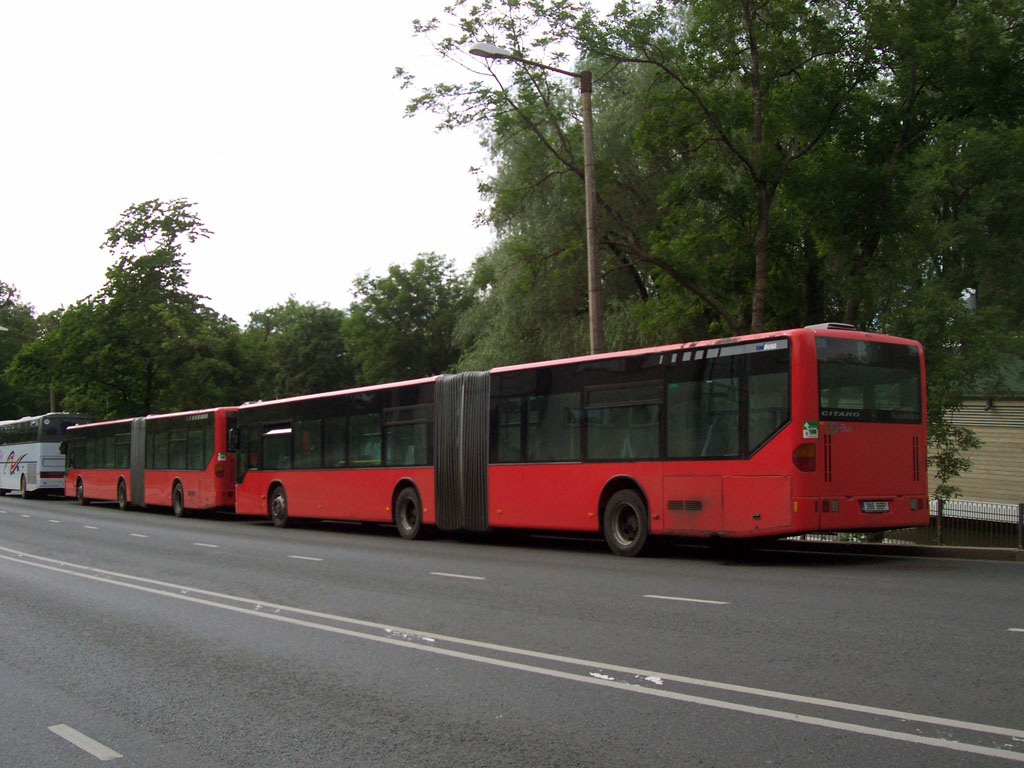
[65,408,238,517]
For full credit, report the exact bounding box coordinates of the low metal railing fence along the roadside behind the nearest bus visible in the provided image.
[798,499,1024,549]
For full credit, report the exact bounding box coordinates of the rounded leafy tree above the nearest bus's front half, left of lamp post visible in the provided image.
[345,253,476,384]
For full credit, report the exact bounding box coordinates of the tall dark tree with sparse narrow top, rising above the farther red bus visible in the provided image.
[12,199,244,418]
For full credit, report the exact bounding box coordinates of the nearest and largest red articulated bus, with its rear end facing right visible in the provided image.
[232,325,929,555]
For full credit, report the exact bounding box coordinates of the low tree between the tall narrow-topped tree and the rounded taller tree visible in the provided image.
[243,297,354,399]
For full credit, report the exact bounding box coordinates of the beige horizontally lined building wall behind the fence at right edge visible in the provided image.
[929,399,1024,504]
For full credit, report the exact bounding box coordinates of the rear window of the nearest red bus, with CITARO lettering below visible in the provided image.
[817,337,921,424]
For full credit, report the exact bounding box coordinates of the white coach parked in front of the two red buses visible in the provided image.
[0,414,92,498]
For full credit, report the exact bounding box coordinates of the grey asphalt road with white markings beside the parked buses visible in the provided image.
[0,497,1024,768]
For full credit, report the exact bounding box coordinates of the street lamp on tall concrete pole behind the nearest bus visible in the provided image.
[469,43,604,354]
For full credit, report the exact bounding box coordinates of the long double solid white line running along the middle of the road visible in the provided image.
[6,547,1024,763]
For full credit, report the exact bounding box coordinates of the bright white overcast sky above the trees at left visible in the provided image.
[0,0,492,326]
